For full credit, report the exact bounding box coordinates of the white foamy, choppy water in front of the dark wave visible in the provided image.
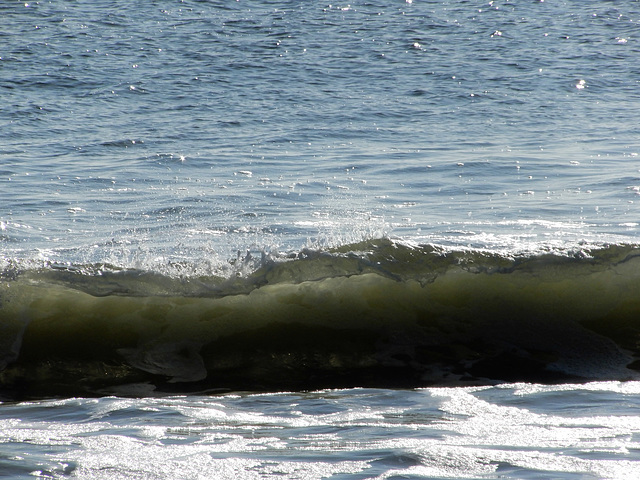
[0,382,640,480]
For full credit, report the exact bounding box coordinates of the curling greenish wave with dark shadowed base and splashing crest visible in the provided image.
[0,240,640,398]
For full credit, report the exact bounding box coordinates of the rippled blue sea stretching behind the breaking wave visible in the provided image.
[5,1,640,264]
